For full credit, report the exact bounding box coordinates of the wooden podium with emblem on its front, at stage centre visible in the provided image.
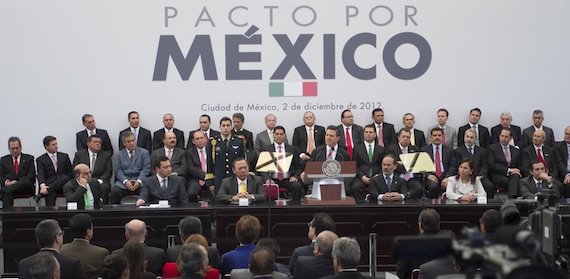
[304,161,356,205]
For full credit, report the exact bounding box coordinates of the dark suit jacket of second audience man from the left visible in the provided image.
[59,239,109,279]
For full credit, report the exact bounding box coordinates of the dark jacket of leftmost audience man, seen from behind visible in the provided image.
[18,248,87,279]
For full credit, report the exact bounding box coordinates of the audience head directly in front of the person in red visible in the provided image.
[179,243,210,275]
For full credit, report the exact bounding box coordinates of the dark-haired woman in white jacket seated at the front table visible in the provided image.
[445,158,487,201]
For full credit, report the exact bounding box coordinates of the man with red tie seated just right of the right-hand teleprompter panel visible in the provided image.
[422,127,456,199]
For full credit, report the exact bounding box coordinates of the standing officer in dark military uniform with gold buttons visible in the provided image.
[210,117,245,193]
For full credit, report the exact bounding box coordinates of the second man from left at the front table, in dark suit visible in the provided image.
[136,156,188,207]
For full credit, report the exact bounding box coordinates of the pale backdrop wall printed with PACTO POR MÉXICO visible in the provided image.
[0,0,570,159]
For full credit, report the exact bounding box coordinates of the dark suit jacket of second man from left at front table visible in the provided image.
[139,175,188,207]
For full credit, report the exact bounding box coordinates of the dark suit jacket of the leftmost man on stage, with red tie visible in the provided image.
[0,154,36,186]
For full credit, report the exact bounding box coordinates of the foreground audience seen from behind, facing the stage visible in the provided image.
[18,208,503,279]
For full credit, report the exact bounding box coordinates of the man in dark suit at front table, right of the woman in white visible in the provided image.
[520,161,562,199]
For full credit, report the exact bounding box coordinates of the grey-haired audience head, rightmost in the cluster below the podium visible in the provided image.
[332,237,360,273]
